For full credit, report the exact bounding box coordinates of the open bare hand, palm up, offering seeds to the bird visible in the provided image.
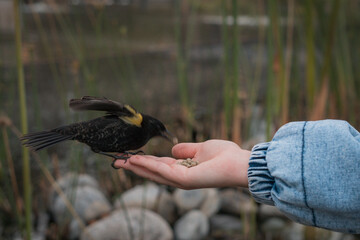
[115,140,250,189]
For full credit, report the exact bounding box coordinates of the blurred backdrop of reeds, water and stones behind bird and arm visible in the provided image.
[0,0,360,239]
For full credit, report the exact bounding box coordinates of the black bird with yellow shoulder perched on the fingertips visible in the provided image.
[20,96,177,169]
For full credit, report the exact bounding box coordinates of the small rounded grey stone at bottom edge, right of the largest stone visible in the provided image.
[174,210,210,240]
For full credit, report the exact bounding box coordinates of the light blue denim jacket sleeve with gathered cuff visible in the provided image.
[248,120,360,233]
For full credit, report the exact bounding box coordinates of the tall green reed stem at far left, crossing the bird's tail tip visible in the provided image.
[13,0,32,239]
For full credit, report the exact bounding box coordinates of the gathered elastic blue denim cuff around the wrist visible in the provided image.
[248,142,275,205]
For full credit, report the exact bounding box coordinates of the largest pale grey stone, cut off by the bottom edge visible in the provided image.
[80,208,173,240]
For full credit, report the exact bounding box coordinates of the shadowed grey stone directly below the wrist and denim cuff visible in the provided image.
[220,188,256,215]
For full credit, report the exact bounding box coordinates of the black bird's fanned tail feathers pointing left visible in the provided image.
[20,131,72,151]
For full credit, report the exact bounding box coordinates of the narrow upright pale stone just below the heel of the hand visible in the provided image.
[200,188,221,217]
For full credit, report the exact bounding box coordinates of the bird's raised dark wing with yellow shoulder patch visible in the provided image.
[69,96,143,127]
